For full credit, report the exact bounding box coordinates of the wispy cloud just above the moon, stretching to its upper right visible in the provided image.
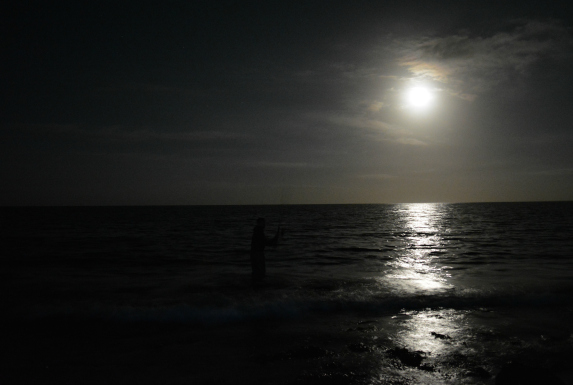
[398,20,573,99]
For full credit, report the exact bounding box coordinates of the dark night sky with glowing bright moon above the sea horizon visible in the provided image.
[0,0,573,205]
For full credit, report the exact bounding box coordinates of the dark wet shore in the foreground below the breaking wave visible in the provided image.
[1,309,573,384]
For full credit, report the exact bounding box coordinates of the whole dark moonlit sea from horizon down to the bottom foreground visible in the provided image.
[0,202,573,384]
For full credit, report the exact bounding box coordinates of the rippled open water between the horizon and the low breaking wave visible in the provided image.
[2,203,573,307]
